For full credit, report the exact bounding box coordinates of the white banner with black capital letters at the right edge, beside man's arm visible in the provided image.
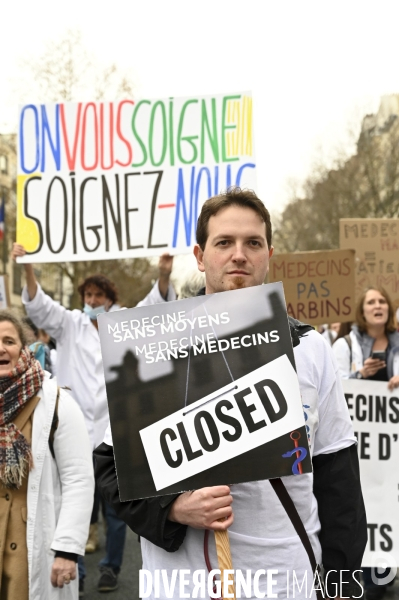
[342,379,399,567]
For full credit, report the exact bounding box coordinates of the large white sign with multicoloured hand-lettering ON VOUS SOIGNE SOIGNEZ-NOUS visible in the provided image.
[17,93,256,262]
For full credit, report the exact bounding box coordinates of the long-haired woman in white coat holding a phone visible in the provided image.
[333,287,399,600]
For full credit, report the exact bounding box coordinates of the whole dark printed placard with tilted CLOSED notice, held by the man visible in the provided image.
[99,284,311,501]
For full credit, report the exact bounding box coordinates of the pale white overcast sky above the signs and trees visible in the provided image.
[0,0,399,218]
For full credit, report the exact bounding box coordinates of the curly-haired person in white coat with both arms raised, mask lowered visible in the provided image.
[13,244,176,596]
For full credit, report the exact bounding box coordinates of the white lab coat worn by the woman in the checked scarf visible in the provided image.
[26,372,94,600]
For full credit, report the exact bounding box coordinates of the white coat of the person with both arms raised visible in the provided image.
[22,282,176,449]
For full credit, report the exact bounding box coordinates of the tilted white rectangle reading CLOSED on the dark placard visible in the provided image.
[140,355,304,490]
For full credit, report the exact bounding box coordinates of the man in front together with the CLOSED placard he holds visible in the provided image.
[96,190,365,598]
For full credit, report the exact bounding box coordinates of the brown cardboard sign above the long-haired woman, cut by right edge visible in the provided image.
[339,219,399,308]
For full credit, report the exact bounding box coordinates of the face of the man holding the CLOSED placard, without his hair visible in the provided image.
[194,206,273,294]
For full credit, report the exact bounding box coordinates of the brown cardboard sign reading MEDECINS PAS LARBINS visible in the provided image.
[269,250,355,325]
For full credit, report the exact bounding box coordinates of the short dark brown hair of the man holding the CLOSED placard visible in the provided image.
[196,187,272,250]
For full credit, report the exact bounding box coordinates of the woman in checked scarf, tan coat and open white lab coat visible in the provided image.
[0,311,94,600]
